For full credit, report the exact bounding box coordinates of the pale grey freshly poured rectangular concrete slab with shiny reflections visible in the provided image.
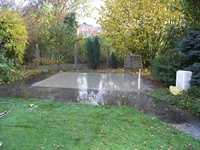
[32,72,138,92]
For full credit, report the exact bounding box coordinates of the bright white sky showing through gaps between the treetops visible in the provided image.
[15,0,103,26]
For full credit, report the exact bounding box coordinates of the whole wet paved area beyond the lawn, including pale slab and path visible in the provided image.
[0,72,200,139]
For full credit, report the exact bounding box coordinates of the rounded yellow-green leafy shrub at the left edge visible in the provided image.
[0,10,27,63]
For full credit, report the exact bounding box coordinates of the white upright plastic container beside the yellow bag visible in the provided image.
[176,70,192,91]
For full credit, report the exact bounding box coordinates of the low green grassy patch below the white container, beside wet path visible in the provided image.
[149,86,200,116]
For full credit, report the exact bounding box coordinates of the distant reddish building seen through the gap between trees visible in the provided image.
[77,23,102,37]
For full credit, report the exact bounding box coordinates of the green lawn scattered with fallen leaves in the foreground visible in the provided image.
[0,99,200,150]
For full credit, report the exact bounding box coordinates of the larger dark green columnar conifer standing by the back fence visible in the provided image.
[86,36,100,69]
